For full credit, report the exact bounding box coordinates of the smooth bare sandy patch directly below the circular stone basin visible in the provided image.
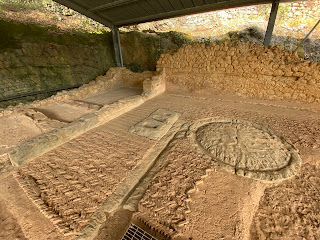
[182,171,265,239]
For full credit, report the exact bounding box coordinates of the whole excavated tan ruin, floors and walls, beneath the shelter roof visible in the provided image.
[0,42,320,240]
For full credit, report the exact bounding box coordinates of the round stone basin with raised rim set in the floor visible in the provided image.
[191,119,301,181]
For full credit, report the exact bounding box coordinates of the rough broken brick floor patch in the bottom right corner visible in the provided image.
[251,163,320,239]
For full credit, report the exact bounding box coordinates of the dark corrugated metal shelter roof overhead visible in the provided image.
[55,0,298,27]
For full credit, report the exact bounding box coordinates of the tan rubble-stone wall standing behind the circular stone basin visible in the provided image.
[157,42,320,102]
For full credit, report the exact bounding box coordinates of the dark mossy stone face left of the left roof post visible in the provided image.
[0,21,115,107]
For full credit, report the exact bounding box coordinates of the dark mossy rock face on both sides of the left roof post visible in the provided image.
[0,20,187,108]
